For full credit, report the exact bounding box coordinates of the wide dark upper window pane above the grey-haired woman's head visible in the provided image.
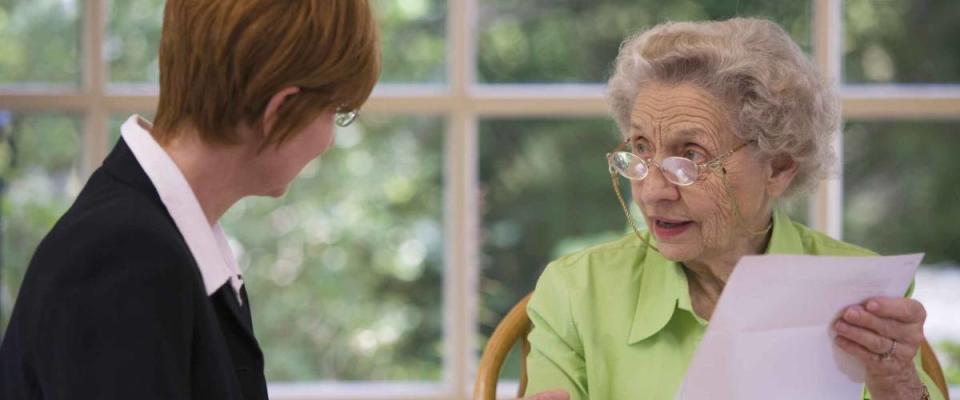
[477,0,812,83]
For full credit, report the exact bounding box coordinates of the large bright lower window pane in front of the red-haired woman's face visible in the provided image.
[224,114,444,381]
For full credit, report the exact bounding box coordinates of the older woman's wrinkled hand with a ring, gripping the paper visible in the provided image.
[834,297,927,400]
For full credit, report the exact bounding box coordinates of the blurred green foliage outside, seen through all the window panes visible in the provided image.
[0,0,960,390]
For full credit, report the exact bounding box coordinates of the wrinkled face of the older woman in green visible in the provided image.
[630,84,769,262]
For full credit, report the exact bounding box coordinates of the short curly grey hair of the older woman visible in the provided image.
[607,18,840,197]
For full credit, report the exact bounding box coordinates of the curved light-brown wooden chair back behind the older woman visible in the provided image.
[473,294,950,400]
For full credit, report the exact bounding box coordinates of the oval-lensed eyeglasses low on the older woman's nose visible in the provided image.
[607,139,754,186]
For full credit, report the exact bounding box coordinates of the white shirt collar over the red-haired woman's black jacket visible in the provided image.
[120,115,243,304]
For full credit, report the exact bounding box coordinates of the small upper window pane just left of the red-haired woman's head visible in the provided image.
[103,0,164,83]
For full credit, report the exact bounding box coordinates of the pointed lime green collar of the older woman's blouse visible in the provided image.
[627,209,803,345]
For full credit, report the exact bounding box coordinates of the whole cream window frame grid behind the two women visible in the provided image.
[0,0,960,400]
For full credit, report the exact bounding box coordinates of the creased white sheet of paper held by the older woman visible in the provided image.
[677,254,923,400]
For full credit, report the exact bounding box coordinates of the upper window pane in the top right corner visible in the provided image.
[844,0,960,83]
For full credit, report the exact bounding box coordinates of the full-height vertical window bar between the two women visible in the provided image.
[443,0,479,399]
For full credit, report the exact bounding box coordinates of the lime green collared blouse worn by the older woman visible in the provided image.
[527,211,942,400]
